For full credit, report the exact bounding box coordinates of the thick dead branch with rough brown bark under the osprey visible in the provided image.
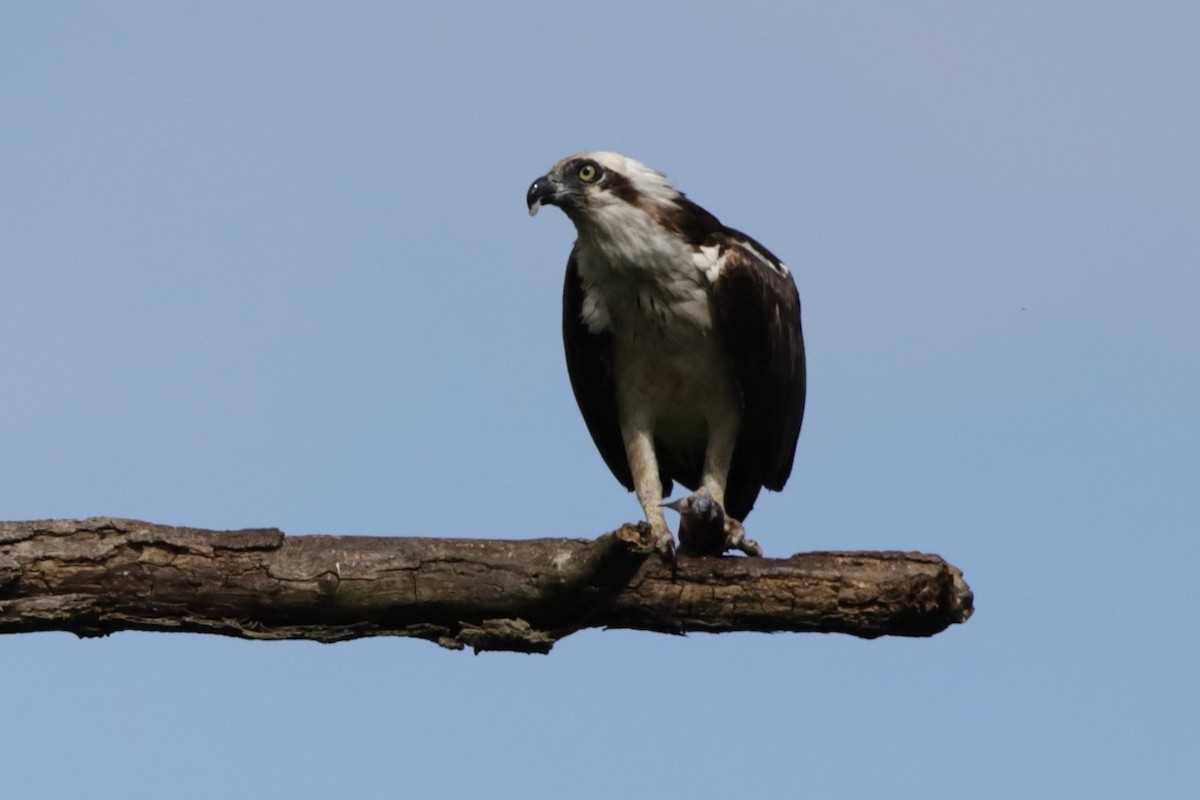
[0,517,972,652]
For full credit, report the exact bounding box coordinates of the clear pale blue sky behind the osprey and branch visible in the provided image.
[0,1,1200,799]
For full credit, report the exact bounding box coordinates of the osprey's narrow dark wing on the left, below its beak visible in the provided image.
[563,249,634,492]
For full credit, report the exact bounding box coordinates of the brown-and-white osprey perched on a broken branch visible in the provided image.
[526,152,805,554]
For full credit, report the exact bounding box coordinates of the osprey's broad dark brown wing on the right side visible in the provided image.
[706,228,805,519]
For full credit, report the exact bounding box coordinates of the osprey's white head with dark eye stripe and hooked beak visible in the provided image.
[526,151,682,228]
